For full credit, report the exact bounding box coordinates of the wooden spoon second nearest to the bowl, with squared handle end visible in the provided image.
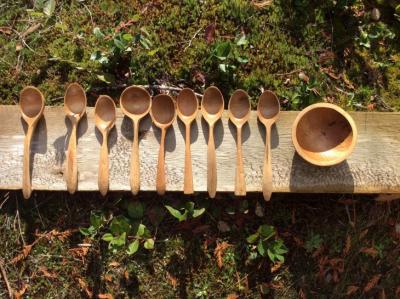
[228,89,251,196]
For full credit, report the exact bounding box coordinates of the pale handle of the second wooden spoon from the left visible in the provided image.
[66,122,78,194]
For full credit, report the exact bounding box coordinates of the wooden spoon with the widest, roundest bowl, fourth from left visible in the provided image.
[119,86,151,195]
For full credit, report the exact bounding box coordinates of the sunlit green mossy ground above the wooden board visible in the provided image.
[0,0,400,110]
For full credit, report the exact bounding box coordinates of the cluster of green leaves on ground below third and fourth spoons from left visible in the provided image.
[80,201,154,255]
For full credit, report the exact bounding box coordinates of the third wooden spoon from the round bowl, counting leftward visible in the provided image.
[201,86,224,198]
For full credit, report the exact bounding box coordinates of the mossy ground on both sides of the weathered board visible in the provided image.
[0,0,400,298]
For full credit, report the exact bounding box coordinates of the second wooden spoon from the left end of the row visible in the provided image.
[64,83,87,194]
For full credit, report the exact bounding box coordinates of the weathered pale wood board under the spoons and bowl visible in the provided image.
[0,106,400,193]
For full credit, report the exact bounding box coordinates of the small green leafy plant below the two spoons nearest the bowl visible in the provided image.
[246,224,288,263]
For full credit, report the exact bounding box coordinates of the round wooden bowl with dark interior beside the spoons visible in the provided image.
[292,103,357,166]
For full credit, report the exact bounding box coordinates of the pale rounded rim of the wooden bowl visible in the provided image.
[292,103,358,166]
